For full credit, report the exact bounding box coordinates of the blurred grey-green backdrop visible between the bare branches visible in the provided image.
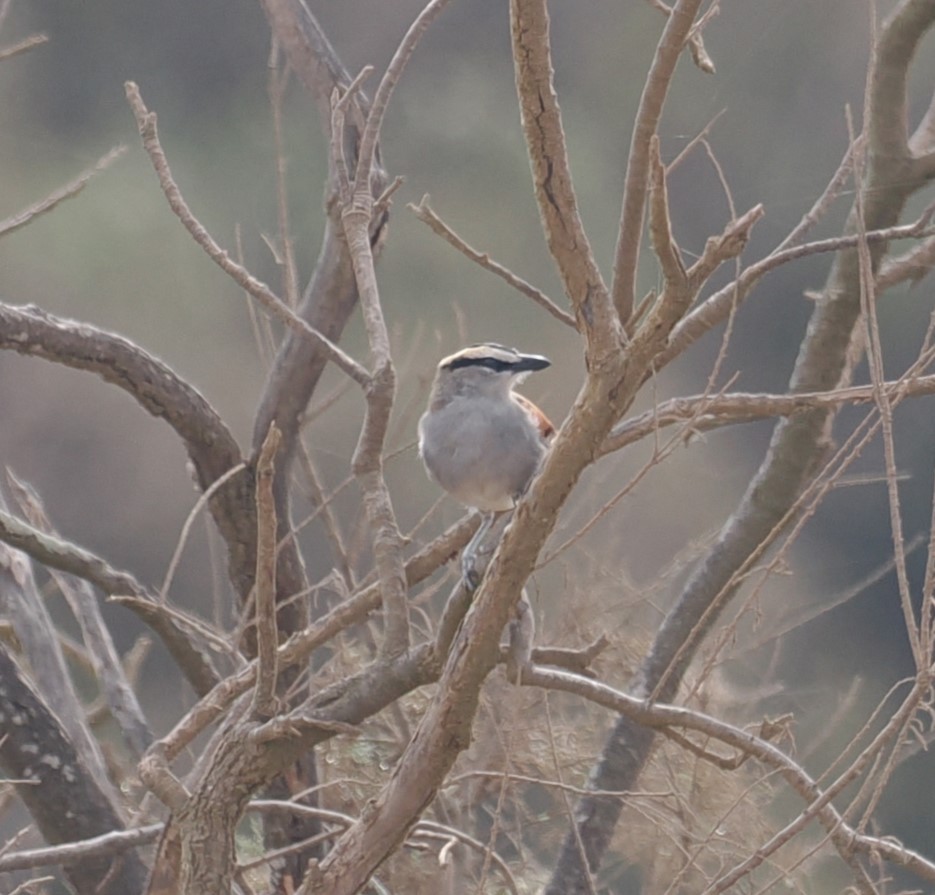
[0,0,935,888]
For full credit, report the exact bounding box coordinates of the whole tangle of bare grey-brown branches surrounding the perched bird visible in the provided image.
[0,0,935,895]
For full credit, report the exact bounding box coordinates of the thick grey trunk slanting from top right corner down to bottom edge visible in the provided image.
[546,0,935,895]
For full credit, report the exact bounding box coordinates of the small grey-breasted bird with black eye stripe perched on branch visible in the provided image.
[419,342,555,590]
